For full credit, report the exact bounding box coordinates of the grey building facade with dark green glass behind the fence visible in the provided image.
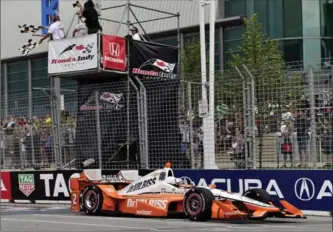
[0,0,333,117]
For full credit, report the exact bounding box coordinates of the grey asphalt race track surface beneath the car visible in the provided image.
[0,204,332,232]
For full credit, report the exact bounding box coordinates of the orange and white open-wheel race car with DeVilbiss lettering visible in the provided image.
[70,163,305,221]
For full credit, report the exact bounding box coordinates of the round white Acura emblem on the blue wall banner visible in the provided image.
[295,177,315,201]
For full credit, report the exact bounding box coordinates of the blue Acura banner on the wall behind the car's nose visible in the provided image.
[175,170,333,211]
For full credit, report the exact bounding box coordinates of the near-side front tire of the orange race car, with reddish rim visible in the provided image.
[183,187,214,221]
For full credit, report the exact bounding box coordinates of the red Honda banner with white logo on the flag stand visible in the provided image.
[102,35,126,71]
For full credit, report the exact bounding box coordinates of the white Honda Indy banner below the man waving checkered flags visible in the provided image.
[48,34,98,74]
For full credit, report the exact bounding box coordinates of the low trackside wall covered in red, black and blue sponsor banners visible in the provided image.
[1,170,333,214]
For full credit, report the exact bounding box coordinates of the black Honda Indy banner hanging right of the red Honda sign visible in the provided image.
[129,40,178,80]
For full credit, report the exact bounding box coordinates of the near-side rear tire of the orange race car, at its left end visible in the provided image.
[80,185,103,215]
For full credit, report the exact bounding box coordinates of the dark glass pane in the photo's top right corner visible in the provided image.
[320,0,333,37]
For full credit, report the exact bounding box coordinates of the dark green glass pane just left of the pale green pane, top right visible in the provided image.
[283,0,300,38]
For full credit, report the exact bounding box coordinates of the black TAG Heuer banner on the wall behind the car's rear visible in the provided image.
[10,170,150,201]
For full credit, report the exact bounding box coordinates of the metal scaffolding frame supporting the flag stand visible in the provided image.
[48,0,181,169]
